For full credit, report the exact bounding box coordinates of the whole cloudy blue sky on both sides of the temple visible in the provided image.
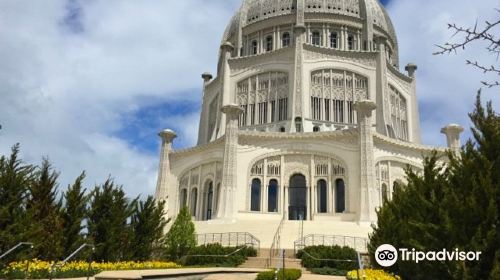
[0,0,500,197]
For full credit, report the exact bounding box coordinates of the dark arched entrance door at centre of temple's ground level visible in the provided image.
[288,174,307,221]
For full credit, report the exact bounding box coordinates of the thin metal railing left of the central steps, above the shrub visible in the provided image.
[196,232,260,250]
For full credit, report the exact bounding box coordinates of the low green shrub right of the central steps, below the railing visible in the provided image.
[297,245,358,271]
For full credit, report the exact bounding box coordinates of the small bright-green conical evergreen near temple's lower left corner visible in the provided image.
[166,207,196,261]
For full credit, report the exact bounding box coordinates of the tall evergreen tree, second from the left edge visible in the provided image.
[27,159,63,260]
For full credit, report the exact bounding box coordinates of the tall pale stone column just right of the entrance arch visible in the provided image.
[355,100,377,222]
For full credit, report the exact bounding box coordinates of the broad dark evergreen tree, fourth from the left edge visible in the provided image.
[88,179,137,261]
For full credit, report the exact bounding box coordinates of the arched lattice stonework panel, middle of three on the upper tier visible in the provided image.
[309,69,368,124]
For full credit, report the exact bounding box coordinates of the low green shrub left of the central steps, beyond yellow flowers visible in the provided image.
[182,243,257,267]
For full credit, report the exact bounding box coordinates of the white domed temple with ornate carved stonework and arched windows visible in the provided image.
[156,0,462,248]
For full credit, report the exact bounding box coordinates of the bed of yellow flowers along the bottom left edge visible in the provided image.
[0,259,180,279]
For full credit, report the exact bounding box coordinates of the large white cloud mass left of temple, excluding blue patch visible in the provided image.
[0,0,239,196]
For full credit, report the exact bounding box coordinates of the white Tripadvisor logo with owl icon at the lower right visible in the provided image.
[375,244,481,267]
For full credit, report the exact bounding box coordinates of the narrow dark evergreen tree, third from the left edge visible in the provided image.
[62,172,88,258]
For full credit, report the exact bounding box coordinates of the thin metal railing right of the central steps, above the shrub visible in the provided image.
[293,234,368,253]
